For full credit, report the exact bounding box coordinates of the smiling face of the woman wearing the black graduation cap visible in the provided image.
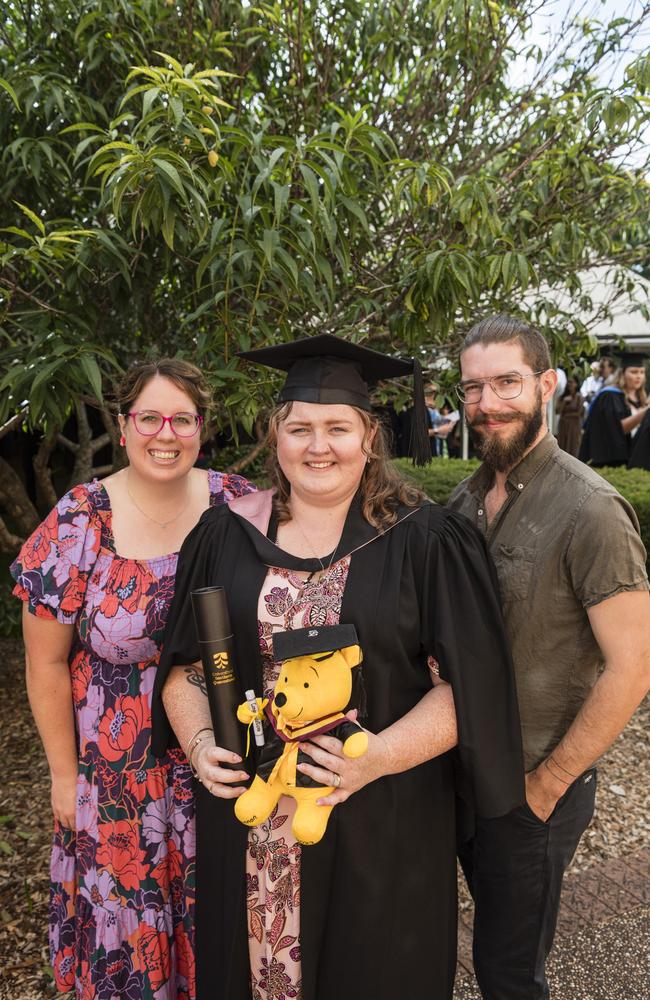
[277,402,374,504]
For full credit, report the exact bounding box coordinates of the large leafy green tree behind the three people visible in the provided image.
[0,0,650,548]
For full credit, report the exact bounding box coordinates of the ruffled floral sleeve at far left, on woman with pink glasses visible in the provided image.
[10,485,101,625]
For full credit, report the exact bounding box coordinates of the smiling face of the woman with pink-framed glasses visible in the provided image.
[118,375,201,482]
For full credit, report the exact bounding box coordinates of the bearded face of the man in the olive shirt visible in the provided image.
[460,340,557,472]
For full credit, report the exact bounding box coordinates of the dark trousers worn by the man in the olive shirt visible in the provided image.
[458,768,596,1000]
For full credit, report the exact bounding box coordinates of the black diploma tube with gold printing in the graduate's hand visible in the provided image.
[190,587,246,770]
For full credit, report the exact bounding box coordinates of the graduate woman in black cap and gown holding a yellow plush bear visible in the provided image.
[154,336,524,1000]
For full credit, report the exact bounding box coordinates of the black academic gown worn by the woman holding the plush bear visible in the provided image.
[153,503,524,1000]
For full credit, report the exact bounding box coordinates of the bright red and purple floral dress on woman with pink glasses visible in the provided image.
[12,470,253,1000]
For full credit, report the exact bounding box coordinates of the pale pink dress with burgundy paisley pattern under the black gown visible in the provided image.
[246,556,350,1000]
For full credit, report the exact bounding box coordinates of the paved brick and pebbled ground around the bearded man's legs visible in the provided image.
[454,848,650,1000]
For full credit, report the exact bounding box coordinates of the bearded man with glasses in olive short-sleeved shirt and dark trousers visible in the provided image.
[450,316,650,1000]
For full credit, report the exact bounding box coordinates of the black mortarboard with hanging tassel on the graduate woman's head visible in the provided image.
[239,334,431,465]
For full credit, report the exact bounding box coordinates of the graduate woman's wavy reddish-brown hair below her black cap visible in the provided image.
[266,402,426,531]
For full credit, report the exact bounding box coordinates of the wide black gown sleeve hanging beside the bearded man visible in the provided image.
[422,506,524,817]
